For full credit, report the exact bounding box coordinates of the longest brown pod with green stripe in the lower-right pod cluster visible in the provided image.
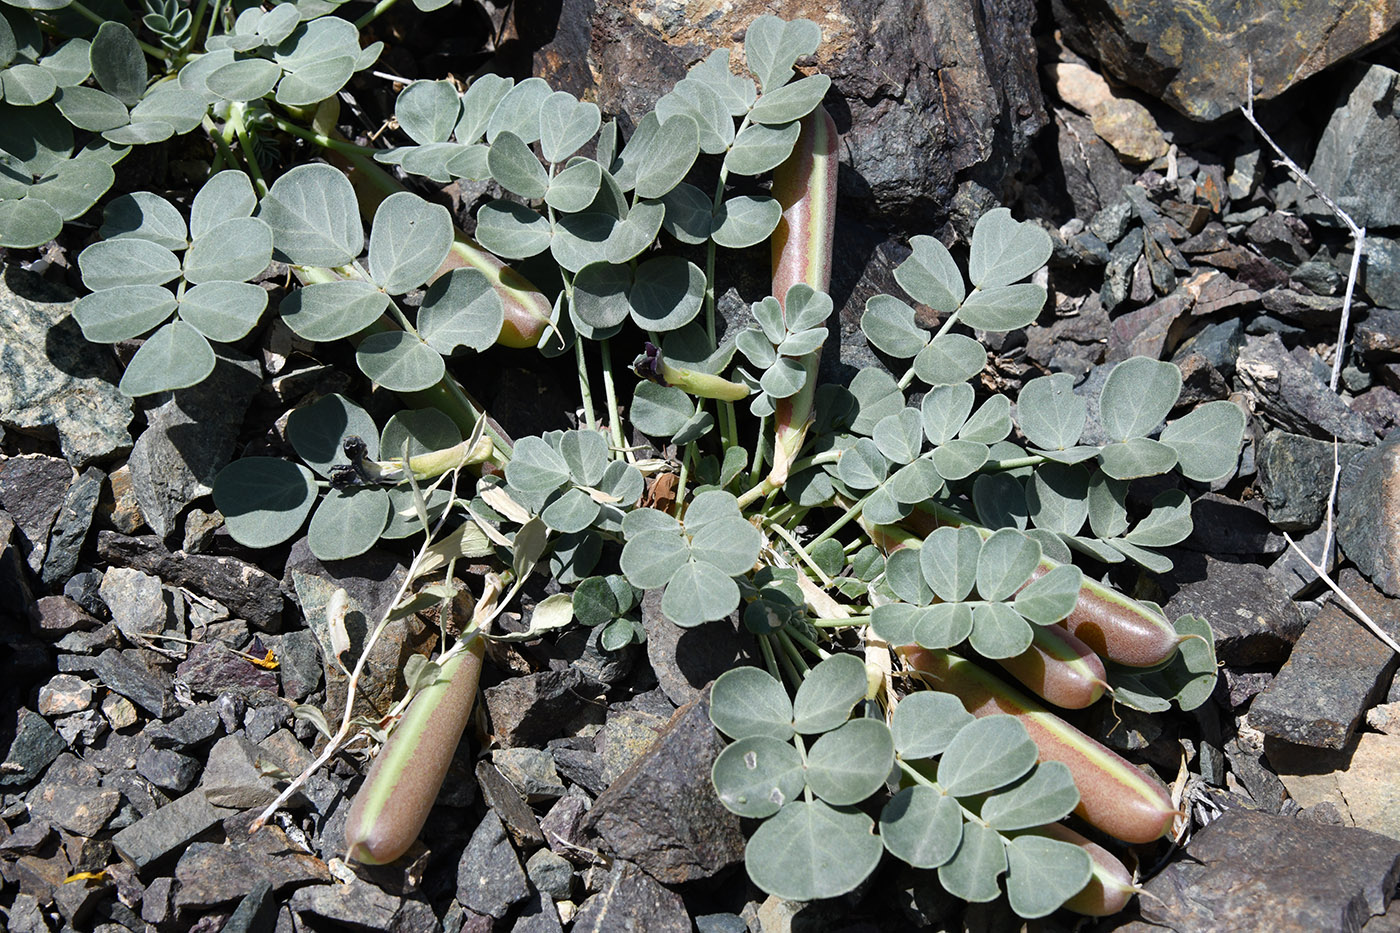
[899,646,1176,843]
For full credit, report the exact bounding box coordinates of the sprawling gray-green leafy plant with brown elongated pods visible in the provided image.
[32,8,1243,918]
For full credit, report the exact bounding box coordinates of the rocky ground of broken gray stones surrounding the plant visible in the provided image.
[0,0,1400,933]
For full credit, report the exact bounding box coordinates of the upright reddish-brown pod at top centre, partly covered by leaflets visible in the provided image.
[769,106,839,486]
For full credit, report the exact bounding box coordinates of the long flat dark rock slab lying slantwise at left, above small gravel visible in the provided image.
[98,531,283,632]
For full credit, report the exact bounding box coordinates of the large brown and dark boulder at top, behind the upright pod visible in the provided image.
[525,0,1047,230]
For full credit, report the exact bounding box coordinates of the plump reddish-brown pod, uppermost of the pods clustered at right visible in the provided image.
[900,504,1182,667]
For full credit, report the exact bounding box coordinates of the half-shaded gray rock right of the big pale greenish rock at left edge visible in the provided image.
[127,347,262,539]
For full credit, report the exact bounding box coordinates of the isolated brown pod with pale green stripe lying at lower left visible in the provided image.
[346,635,486,864]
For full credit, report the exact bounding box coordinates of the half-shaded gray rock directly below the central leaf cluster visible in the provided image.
[641,590,757,706]
